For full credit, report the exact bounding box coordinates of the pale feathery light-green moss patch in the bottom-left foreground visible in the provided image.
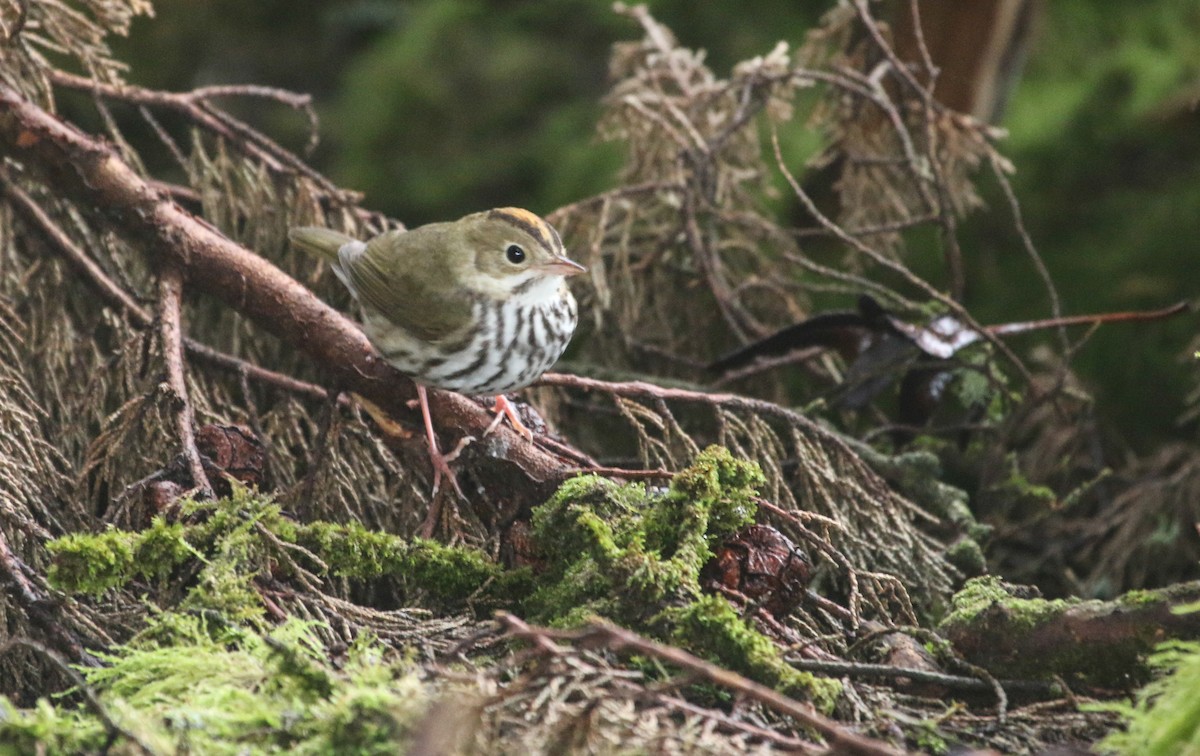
[0,614,427,754]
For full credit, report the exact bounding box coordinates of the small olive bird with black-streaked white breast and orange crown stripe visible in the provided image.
[289,208,587,496]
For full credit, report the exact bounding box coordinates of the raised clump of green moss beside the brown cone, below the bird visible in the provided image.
[526,446,841,710]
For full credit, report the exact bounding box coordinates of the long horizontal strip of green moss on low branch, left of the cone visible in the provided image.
[48,490,504,619]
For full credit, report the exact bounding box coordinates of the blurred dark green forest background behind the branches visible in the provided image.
[108,0,1200,451]
